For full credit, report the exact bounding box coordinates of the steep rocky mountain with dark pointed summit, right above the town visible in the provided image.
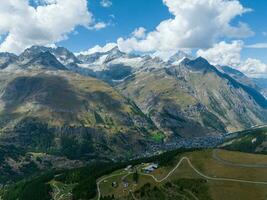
[117,58,267,136]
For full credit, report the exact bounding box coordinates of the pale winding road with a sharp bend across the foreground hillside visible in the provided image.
[97,157,267,200]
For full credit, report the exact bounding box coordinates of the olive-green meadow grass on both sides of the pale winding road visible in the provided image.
[96,150,267,200]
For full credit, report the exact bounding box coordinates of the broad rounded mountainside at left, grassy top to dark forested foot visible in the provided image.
[0,66,159,182]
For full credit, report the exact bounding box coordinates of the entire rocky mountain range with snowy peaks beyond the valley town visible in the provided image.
[0,46,267,181]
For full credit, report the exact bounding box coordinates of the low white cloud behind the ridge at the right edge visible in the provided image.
[197,41,267,77]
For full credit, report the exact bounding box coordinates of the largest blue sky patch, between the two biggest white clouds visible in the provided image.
[59,0,171,51]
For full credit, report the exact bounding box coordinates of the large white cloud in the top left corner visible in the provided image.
[0,0,94,53]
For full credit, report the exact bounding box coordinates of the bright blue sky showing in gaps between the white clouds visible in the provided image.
[55,0,267,63]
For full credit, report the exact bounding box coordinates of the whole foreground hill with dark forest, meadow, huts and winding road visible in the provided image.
[0,149,267,200]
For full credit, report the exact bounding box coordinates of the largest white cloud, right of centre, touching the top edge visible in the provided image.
[117,0,253,57]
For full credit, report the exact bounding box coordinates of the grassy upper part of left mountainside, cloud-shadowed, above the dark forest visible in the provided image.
[0,72,153,126]
